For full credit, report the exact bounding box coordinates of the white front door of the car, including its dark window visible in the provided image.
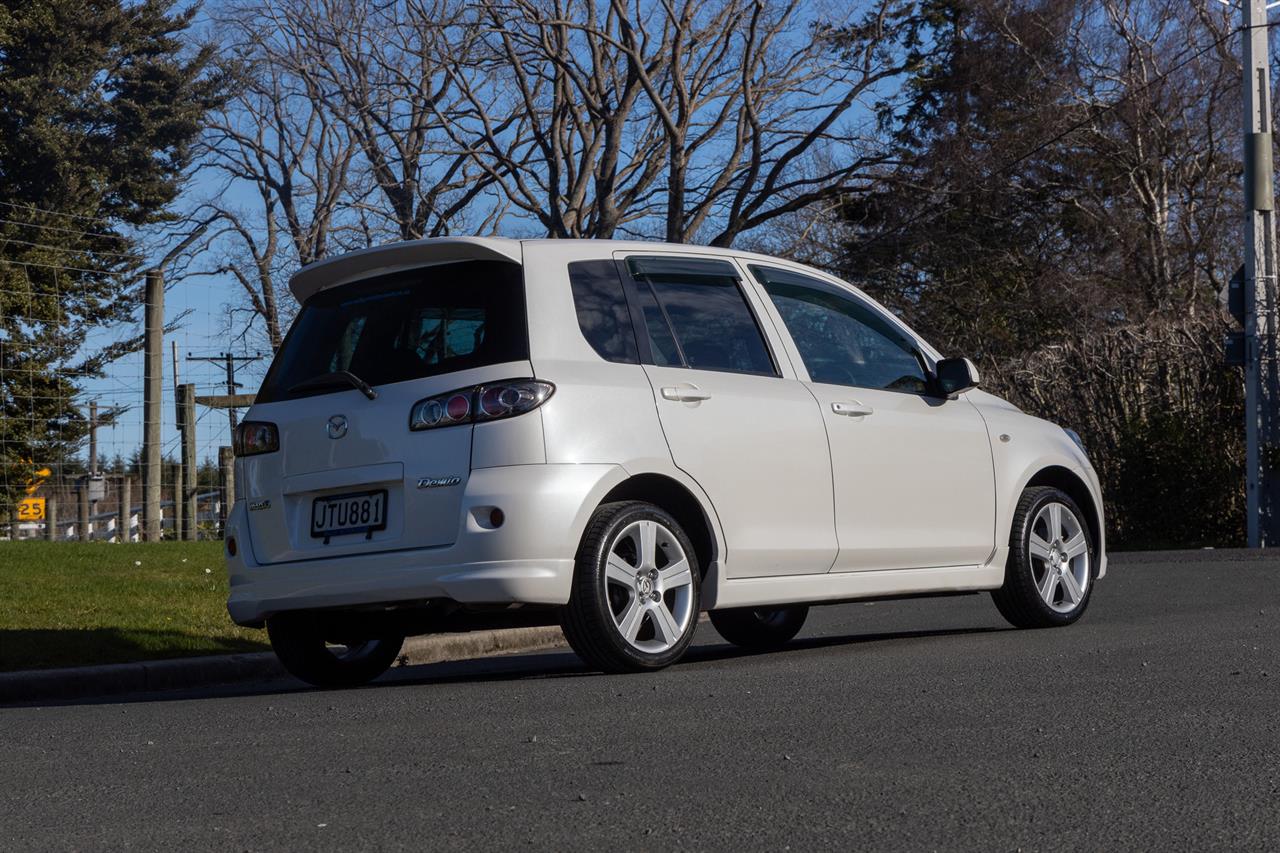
[750,264,996,571]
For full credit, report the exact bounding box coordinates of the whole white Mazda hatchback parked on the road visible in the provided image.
[225,237,1106,686]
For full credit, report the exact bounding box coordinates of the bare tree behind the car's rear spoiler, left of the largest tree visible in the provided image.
[266,0,500,240]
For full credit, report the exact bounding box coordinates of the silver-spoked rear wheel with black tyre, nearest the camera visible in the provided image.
[561,501,700,672]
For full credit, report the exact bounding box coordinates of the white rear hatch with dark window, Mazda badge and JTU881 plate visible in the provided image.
[242,260,532,562]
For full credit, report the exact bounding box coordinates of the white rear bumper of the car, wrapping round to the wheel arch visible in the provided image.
[227,465,625,625]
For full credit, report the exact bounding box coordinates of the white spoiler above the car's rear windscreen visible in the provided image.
[289,237,524,302]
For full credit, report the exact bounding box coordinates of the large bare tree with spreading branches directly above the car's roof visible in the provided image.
[442,0,918,246]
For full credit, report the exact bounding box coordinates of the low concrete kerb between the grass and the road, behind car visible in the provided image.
[0,628,566,703]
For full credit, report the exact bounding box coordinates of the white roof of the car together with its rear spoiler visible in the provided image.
[289,237,808,302]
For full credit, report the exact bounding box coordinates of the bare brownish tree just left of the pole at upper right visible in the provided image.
[1060,0,1240,311]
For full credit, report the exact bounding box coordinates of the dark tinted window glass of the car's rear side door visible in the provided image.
[628,257,777,375]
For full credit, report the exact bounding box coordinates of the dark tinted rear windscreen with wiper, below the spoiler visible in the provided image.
[257,261,529,402]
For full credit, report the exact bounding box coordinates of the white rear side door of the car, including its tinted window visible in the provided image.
[620,249,837,578]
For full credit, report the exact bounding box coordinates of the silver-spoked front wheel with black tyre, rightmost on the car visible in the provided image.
[991,487,1097,628]
